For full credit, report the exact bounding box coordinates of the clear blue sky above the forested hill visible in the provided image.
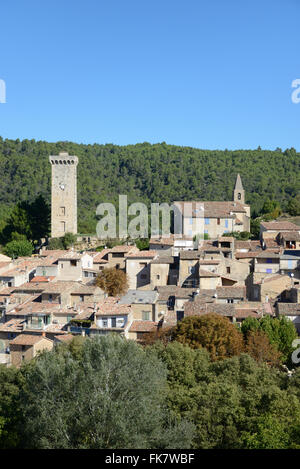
[0,0,300,151]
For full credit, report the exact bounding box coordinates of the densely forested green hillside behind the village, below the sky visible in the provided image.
[0,137,300,232]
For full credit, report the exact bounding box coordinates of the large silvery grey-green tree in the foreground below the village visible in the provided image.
[21,335,193,449]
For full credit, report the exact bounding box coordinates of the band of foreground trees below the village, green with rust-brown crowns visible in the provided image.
[0,315,300,449]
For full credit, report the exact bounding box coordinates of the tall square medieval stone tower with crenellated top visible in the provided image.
[49,152,78,238]
